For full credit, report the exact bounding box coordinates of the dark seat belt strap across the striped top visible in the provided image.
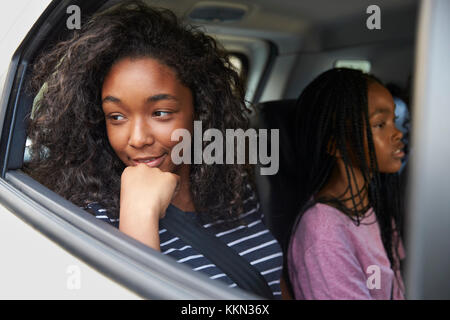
[160,205,273,299]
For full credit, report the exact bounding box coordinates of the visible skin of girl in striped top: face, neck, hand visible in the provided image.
[102,58,195,250]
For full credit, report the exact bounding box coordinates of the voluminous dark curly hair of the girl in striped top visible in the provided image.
[24,1,253,225]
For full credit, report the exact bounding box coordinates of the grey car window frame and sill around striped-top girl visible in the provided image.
[0,1,257,299]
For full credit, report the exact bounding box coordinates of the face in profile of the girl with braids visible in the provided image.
[367,82,405,173]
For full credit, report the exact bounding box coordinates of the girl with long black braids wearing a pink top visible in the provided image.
[287,68,404,299]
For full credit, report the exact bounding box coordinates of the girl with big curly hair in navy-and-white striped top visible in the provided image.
[25,1,282,297]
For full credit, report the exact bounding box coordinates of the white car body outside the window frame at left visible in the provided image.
[0,0,140,299]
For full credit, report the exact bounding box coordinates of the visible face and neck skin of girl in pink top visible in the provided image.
[316,82,405,209]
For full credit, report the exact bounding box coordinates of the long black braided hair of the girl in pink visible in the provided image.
[290,68,404,288]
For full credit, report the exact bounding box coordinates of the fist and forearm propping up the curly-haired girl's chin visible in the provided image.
[119,164,179,251]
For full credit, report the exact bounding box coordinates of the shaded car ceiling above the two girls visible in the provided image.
[136,0,419,52]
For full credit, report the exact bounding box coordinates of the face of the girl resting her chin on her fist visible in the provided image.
[102,58,194,173]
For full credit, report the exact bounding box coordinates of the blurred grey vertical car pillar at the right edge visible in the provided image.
[406,0,450,299]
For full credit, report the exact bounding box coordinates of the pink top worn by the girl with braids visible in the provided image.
[288,203,404,300]
